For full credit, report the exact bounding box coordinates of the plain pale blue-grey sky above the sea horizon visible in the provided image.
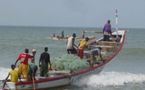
[0,0,145,28]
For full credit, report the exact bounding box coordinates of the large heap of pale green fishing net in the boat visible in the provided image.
[52,54,89,71]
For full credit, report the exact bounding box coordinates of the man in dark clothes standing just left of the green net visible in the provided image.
[39,47,51,77]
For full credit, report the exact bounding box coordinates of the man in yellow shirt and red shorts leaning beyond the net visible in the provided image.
[77,37,89,59]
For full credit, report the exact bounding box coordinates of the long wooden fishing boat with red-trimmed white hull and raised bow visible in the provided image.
[4,30,126,90]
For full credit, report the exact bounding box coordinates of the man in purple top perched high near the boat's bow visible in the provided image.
[103,20,112,41]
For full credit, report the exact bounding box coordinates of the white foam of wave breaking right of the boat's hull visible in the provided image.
[75,72,145,87]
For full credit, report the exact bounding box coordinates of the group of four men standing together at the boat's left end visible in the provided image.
[3,47,51,87]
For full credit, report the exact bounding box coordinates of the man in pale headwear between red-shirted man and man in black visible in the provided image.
[29,49,38,80]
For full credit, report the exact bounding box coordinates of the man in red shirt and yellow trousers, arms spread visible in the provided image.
[15,49,33,80]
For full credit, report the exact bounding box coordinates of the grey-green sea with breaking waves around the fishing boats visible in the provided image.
[0,26,145,90]
